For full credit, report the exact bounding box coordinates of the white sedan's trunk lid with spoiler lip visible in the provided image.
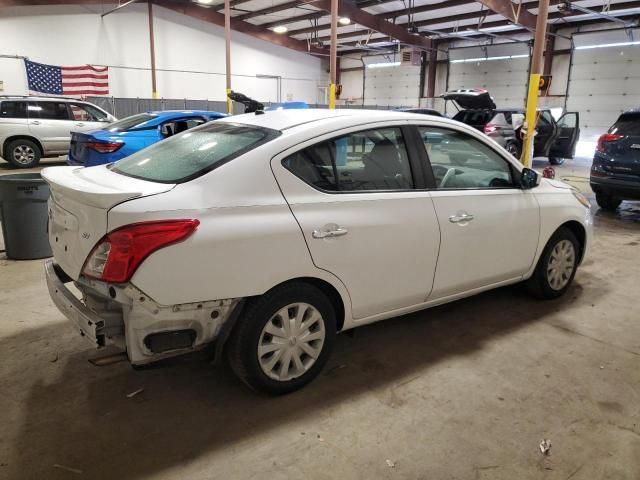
[42,165,175,280]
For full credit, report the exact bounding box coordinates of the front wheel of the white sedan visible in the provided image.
[525,227,580,299]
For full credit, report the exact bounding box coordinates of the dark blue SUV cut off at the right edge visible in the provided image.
[590,110,640,211]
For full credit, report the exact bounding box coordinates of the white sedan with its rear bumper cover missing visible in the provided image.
[42,110,592,394]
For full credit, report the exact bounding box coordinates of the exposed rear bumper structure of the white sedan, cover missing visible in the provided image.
[45,260,241,365]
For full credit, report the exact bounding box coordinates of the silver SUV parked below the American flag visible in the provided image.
[0,96,116,168]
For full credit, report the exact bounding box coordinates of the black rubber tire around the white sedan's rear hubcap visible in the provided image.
[226,282,336,395]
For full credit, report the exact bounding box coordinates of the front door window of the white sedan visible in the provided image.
[418,127,514,189]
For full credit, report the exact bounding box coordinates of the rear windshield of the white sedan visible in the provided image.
[110,123,280,183]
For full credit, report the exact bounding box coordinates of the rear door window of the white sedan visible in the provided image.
[282,128,413,192]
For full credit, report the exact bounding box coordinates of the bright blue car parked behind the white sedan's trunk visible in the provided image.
[67,110,226,167]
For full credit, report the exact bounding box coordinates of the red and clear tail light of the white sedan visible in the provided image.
[82,220,200,283]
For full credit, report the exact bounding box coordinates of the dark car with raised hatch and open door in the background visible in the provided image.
[443,89,580,165]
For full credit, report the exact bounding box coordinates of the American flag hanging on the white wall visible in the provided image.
[24,60,109,96]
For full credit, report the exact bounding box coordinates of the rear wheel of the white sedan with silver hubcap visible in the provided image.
[227,282,336,395]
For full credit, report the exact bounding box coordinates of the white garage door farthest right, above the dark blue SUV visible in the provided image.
[567,29,640,142]
